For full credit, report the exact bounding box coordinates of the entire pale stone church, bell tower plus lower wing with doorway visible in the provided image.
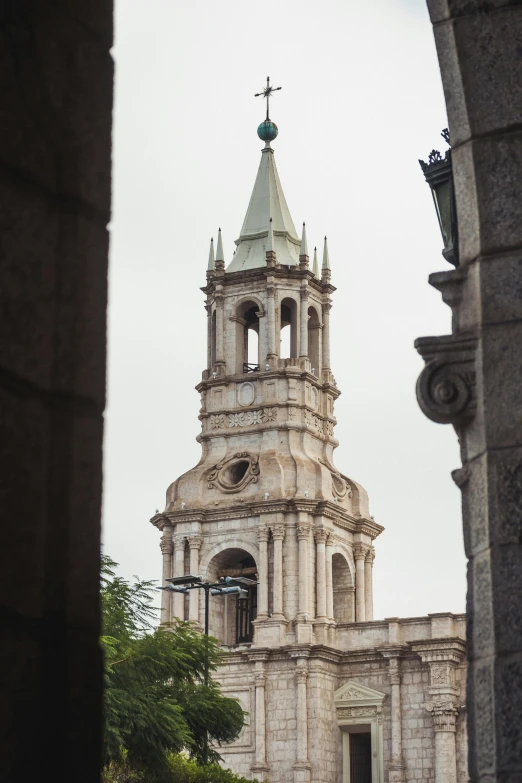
[151,85,468,783]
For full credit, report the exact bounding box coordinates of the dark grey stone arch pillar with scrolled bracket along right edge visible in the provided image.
[417,0,522,783]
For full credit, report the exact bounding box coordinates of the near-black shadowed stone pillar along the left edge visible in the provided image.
[0,0,113,783]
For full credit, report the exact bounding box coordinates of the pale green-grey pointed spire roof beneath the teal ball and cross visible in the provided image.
[227,142,301,272]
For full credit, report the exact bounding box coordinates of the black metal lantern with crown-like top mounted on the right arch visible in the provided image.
[419,128,459,266]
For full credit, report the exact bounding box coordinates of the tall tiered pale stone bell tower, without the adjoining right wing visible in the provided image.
[151,93,383,783]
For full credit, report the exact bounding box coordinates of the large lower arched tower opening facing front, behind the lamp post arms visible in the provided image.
[207,548,257,646]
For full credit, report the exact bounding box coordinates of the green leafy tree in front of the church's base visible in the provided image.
[101,556,245,783]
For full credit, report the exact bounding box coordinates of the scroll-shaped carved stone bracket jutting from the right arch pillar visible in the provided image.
[415,332,477,427]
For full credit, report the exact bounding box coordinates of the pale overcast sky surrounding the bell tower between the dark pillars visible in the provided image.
[103,0,465,619]
